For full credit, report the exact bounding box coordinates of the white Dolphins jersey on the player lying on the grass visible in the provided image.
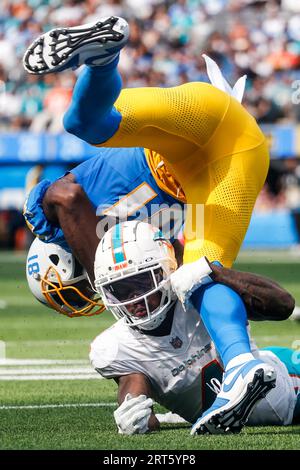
[90,302,223,422]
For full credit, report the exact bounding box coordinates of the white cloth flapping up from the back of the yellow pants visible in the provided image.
[202,54,247,103]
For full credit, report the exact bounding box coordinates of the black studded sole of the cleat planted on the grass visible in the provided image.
[195,369,276,434]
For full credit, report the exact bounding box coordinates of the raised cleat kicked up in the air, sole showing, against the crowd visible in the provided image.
[23,16,129,75]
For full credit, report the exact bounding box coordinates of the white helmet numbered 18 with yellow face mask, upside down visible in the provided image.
[26,238,105,317]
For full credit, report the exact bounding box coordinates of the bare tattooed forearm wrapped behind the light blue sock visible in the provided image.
[209,263,295,321]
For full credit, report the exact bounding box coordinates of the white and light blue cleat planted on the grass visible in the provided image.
[191,359,276,436]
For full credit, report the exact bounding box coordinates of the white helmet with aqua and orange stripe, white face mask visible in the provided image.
[94,220,177,330]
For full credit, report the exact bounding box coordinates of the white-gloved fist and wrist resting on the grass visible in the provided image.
[114,373,159,434]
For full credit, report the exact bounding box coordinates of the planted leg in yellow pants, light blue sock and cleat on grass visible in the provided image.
[184,143,275,432]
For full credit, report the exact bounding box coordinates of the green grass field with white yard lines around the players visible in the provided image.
[0,252,300,450]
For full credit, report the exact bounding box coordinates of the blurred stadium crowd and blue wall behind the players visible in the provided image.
[0,0,300,249]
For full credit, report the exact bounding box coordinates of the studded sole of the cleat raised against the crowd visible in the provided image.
[23,16,125,75]
